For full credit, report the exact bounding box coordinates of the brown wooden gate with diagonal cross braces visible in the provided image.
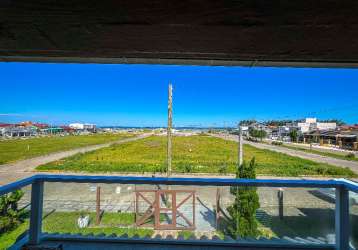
[135,189,195,230]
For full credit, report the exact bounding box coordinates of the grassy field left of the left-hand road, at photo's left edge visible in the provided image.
[0,134,134,164]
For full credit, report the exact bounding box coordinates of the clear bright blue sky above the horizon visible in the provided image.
[0,63,358,126]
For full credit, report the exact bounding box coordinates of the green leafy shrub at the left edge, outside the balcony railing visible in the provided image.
[0,190,25,234]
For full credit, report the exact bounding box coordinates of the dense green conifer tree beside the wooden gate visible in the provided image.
[227,157,260,239]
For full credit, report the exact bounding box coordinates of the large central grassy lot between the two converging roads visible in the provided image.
[37,136,356,177]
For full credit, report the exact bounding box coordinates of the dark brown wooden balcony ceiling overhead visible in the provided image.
[0,0,358,67]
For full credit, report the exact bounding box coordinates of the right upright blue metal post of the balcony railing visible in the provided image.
[335,187,349,250]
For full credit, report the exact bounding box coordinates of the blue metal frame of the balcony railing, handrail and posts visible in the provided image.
[0,175,358,250]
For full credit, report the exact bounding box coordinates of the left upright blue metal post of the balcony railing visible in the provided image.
[29,181,43,245]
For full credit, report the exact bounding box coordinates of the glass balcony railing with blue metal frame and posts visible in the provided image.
[0,175,358,250]
